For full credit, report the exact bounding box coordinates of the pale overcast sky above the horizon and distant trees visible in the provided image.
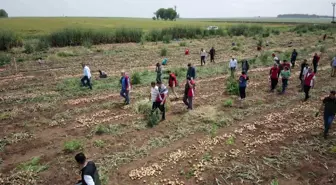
[0,0,336,18]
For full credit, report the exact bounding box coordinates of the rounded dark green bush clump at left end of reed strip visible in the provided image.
[0,30,23,51]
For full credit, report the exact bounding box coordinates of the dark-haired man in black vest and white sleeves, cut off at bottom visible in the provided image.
[75,153,101,185]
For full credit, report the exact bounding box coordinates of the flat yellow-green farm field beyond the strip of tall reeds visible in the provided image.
[0,17,294,36]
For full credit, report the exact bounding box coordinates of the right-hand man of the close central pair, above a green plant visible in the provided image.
[152,82,168,121]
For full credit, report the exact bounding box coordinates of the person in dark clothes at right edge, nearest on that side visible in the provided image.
[316,91,336,139]
